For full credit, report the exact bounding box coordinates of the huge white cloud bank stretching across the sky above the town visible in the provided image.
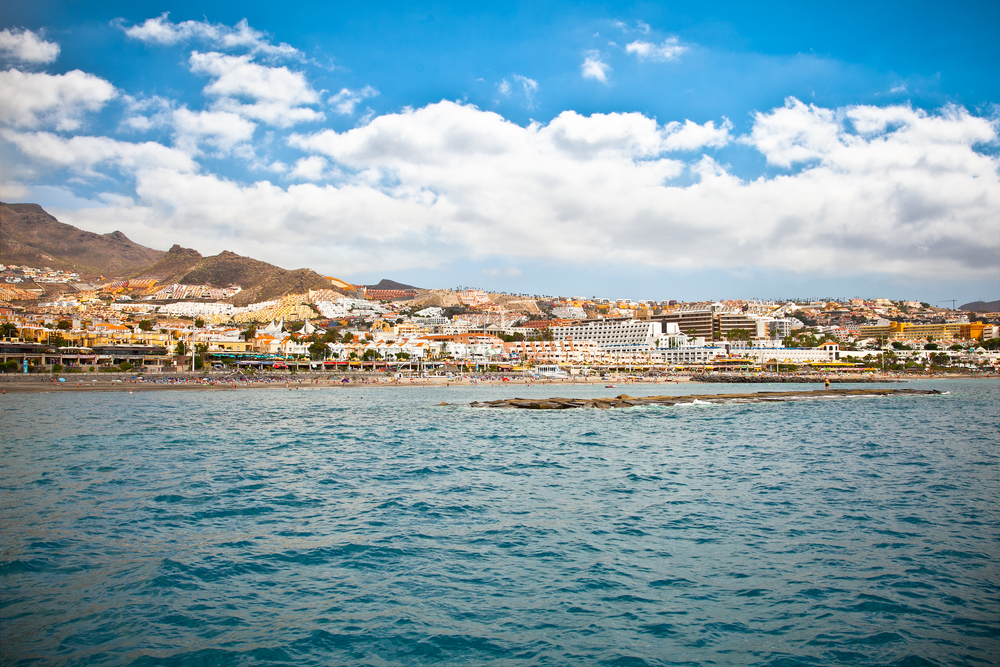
[5,99,1000,279]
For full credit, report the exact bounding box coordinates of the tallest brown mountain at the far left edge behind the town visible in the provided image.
[0,202,166,277]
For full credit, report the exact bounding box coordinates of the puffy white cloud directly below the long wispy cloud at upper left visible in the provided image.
[190,51,326,127]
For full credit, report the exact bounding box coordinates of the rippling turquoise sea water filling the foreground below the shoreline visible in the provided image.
[0,381,1000,666]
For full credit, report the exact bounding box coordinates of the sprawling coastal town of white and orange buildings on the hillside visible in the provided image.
[0,265,1000,377]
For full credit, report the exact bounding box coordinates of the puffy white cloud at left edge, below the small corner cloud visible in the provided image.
[0,69,117,131]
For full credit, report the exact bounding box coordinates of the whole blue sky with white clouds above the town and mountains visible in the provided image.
[0,0,1000,305]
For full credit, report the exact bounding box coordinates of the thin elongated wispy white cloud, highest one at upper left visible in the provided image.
[119,12,302,58]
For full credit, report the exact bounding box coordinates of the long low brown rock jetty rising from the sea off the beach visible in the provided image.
[469,389,941,410]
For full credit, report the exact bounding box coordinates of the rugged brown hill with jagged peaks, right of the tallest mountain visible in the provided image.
[132,245,343,306]
